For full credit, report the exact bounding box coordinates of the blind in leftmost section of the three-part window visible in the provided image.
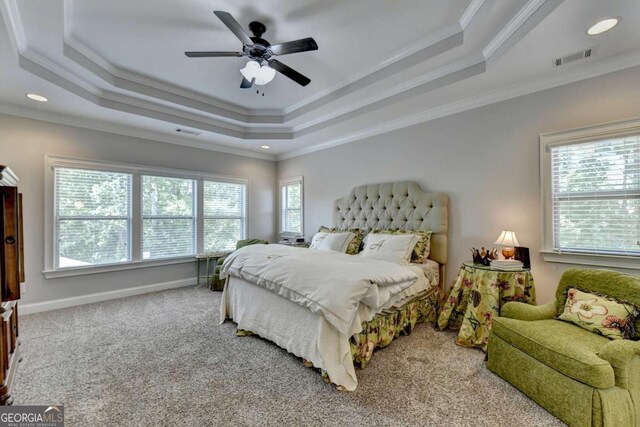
[54,168,131,268]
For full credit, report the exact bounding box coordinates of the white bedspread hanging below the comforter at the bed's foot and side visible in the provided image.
[220,262,439,390]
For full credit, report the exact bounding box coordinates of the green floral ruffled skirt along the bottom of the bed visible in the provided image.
[236,288,442,382]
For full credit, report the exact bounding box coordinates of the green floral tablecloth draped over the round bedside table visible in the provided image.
[437,263,536,351]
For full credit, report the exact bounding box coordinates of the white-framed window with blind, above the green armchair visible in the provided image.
[541,118,640,267]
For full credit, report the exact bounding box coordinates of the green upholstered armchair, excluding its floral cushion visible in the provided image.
[487,269,640,427]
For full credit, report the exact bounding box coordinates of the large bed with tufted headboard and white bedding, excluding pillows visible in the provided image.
[220,182,448,390]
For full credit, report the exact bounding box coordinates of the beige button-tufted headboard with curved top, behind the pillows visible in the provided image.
[333,182,449,265]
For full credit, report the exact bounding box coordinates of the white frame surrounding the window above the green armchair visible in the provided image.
[540,119,640,270]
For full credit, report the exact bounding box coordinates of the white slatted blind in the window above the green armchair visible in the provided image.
[550,135,640,256]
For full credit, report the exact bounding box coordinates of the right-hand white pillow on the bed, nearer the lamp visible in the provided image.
[360,233,420,265]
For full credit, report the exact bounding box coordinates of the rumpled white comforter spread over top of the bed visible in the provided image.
[221,245,418,337]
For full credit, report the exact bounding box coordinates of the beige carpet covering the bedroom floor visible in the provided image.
[14,287,562,427]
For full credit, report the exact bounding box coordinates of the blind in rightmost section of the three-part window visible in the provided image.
[203,180,247,252]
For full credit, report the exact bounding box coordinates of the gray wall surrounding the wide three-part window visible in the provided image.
[0,115,277,304]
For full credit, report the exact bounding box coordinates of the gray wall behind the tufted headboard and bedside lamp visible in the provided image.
[278,68,640,302]
